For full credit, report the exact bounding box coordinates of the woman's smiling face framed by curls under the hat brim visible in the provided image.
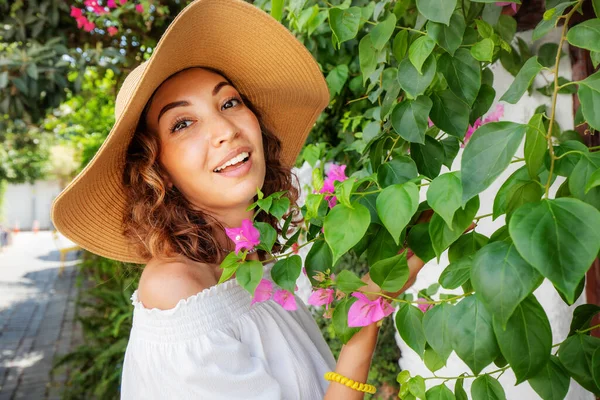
[146,68,265,215]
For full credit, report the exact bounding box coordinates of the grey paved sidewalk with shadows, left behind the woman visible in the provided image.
[0,232,82,400]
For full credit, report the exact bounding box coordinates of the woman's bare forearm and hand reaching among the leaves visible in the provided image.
[324,256,425,400]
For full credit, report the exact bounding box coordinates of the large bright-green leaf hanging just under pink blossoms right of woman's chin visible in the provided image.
[323,203,371,264]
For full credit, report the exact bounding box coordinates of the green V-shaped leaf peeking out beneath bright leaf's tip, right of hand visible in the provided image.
[429,196,479,258]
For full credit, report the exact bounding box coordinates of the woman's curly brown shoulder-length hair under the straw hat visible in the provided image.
[122,67,299,264]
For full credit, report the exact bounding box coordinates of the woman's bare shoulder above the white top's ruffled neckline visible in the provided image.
[138,259,217,310]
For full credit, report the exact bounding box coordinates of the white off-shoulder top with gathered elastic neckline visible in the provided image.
[121,263,335,400]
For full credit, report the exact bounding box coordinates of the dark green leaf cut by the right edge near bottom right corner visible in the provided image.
[558,334,600,396]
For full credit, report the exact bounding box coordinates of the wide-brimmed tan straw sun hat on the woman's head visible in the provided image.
[52,0,329,264]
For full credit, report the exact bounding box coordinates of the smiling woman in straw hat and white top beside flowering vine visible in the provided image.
[52,0,423,400]
